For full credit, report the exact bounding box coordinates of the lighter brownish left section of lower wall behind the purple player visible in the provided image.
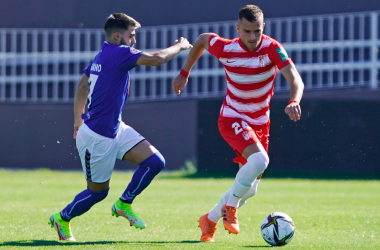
[0,101,197,170]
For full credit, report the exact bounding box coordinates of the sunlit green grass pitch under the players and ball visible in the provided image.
[0,170,380,249]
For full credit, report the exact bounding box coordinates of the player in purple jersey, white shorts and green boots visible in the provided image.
[49,13,192,241]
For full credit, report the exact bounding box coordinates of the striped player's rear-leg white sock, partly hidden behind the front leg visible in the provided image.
[207,179,260,223]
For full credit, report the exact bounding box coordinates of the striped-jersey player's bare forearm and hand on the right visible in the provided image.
[280,63,304,122]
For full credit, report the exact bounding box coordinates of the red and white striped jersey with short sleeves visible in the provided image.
[208,35,292,125]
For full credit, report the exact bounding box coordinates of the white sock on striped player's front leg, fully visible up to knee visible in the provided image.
[227,152,269,207]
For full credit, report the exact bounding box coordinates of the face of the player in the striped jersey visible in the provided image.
[236,16,265,51]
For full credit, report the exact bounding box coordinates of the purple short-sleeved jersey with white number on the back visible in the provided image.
[82,42,142,138]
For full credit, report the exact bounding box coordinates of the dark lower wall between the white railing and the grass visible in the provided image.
[0,90,380,178]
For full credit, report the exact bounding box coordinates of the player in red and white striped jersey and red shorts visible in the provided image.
[172,5,304,241]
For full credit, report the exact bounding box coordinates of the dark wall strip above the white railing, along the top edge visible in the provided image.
[0,0,380,28]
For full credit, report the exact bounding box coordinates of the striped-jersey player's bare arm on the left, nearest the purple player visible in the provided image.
[172,33,214,95]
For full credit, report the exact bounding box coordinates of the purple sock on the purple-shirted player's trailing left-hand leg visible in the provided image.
[61,188,109,221]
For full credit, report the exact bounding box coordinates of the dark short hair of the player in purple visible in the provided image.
[104,13,141,36]
